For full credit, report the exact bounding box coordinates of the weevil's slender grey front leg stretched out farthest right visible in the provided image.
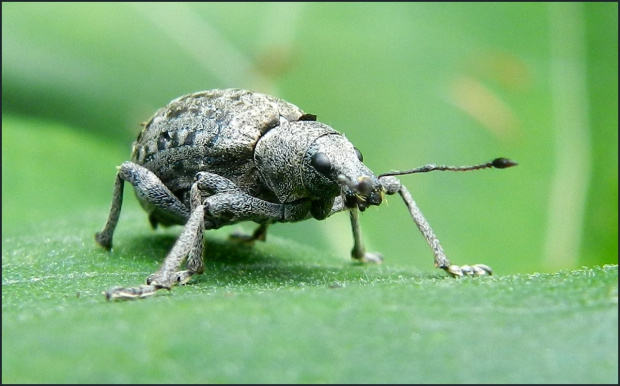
[381,177,493,276]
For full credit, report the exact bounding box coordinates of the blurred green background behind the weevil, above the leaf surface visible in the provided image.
[2,3,618,273]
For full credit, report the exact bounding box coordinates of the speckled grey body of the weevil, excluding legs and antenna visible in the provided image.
[131,89,380,227]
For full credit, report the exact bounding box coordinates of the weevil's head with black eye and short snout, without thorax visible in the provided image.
[303,133,383,211]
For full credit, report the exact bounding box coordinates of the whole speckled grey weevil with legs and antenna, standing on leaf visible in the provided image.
[95,89,516,300]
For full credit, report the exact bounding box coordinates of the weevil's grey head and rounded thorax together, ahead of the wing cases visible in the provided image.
[254,119,384,210]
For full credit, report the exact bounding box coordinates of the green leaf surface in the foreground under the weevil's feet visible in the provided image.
[2,214,618,383]
